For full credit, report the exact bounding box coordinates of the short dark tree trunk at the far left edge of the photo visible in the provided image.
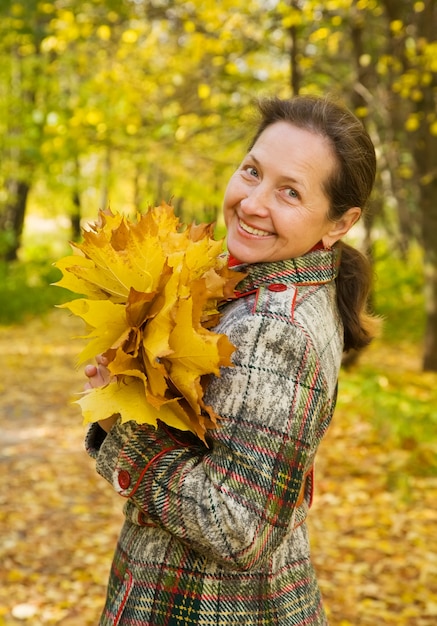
[0,179,30,262]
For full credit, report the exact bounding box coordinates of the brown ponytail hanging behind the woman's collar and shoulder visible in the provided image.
[336,241,380,352]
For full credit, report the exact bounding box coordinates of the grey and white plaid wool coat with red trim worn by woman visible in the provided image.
[87,250,343,626]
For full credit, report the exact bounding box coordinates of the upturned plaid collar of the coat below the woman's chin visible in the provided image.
[229,248,340,295]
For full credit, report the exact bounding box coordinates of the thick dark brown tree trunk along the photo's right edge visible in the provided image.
[378,0,437,371]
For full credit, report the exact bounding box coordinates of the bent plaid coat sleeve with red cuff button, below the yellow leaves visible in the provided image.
[91,298,330,569]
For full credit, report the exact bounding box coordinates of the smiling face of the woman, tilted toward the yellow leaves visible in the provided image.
[223,121,352,263]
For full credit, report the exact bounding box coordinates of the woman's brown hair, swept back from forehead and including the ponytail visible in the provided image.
[249,96,378,352]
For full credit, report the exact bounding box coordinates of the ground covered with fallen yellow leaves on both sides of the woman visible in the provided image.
[0,311,437,626]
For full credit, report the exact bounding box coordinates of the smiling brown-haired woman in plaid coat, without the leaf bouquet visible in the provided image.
[85,97,375,626]
